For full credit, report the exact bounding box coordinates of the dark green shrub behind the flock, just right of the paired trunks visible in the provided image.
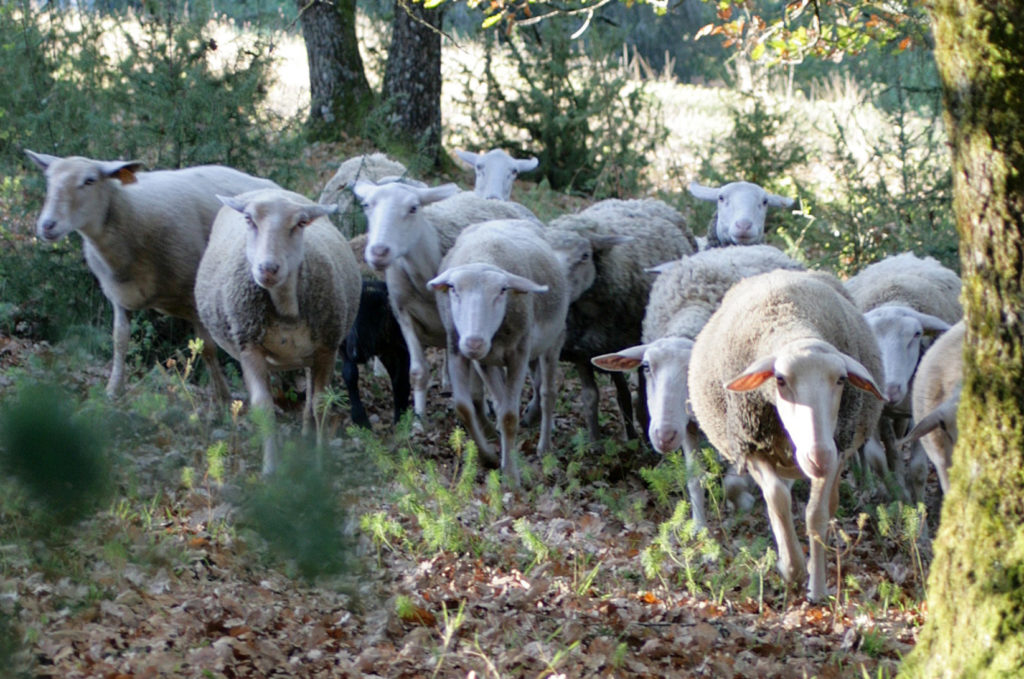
[454,18,668,198]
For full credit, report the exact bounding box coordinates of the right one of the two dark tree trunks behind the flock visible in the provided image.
[382,0,446,166]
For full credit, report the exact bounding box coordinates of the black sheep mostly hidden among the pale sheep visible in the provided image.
[341,278,411,429]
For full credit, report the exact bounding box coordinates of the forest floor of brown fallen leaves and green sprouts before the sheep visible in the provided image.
[0,329,935,679]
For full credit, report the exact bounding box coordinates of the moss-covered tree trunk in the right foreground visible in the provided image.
[902,0,1024,679]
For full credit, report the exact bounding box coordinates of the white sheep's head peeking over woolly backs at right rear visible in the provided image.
[689,181,794,249]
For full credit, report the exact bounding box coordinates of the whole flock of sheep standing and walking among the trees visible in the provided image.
[27,151,964,600]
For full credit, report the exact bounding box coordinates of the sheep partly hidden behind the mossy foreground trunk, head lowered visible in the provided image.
[904,321,966,495]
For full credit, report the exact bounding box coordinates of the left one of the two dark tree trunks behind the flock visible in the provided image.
[296,0,374,139]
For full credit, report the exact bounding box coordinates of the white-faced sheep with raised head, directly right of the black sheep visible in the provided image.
[352,179,540,427]
